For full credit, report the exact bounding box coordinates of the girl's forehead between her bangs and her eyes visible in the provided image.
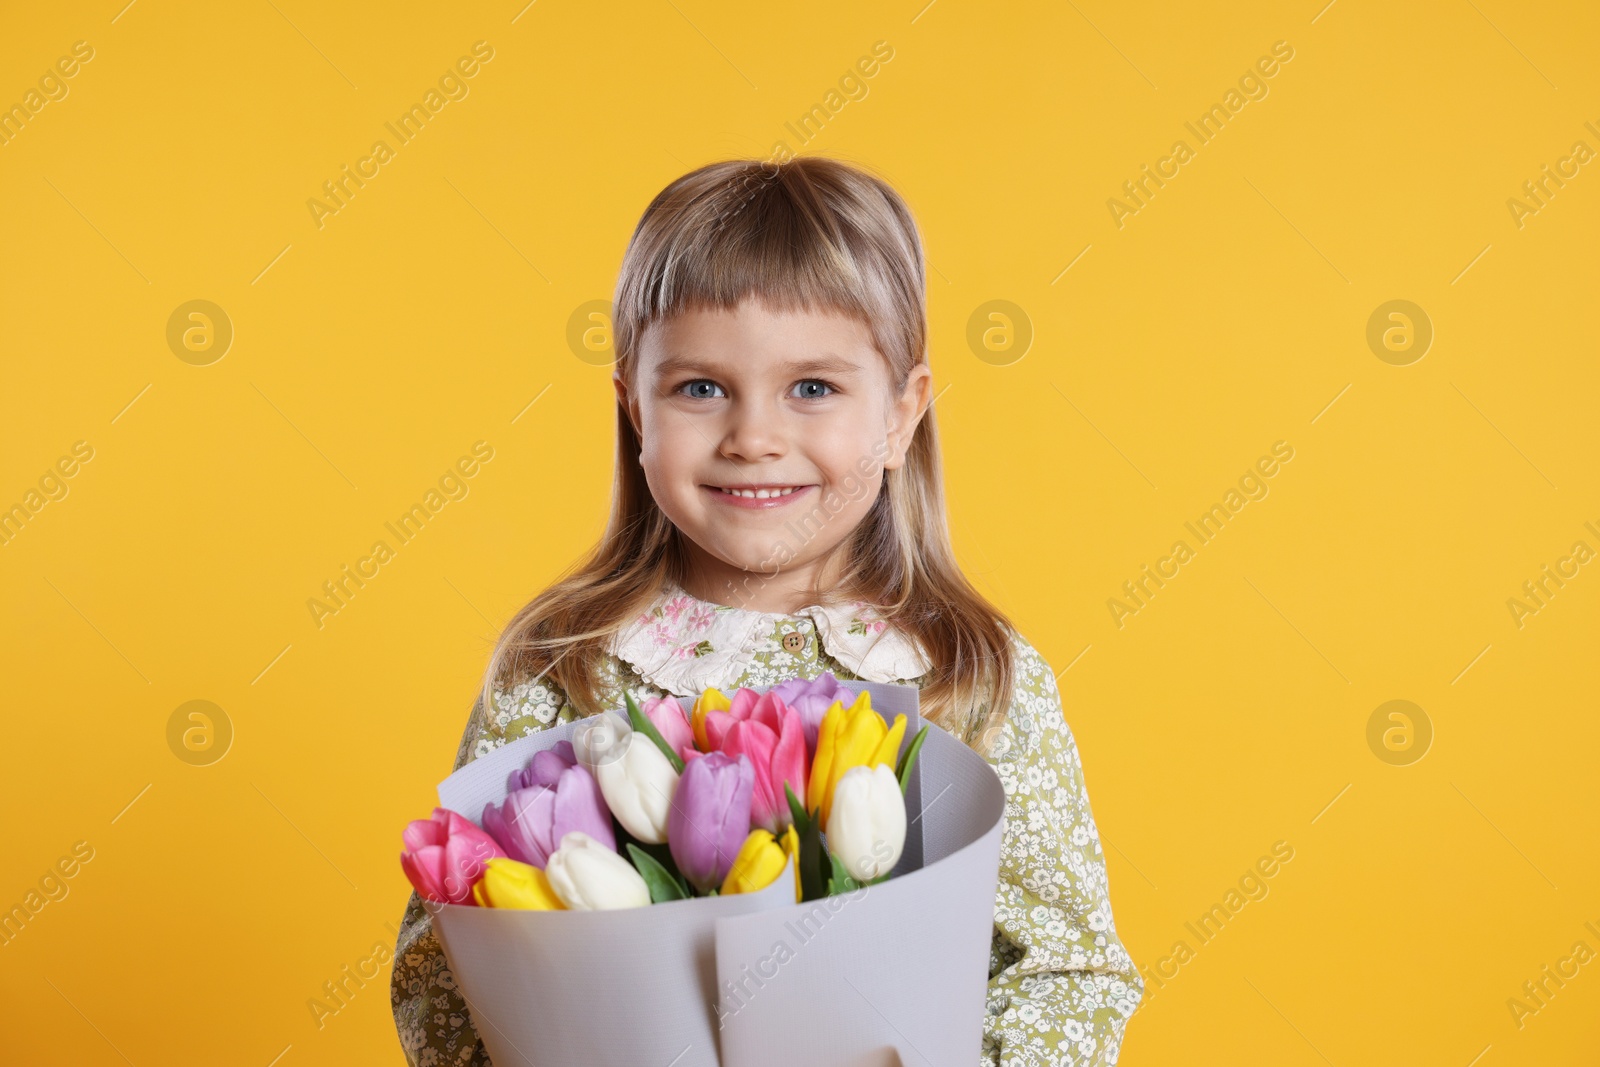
[638,299,886,376]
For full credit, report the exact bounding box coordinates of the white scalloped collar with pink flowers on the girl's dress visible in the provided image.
[611,582,931,697]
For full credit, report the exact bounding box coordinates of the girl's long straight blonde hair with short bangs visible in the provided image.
[483,157,1014,747]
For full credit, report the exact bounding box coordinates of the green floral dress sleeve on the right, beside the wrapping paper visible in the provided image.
[981,637,1144,1067]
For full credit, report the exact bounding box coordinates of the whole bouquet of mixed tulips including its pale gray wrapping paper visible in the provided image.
[400,673,1005,1067]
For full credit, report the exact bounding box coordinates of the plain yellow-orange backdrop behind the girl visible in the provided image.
[0,0,1600,1067]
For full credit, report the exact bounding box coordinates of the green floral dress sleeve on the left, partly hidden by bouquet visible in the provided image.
[389,683,574,1067]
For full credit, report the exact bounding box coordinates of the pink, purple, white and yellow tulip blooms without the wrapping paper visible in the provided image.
[400,673,928,912]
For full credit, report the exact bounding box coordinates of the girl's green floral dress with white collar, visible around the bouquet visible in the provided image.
[390,587,1144,1067]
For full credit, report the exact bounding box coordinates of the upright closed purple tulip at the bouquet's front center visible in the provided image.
[667,752,755,893]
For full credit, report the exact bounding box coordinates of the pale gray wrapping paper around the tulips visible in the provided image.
[429,681,1005,1067]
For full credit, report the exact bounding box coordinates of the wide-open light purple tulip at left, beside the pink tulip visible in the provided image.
[483,741,616,869]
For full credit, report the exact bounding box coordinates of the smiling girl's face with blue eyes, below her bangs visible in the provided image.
[614,299,931,611]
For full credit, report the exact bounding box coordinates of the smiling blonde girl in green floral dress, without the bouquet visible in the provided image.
[392,157,1144,1067]
